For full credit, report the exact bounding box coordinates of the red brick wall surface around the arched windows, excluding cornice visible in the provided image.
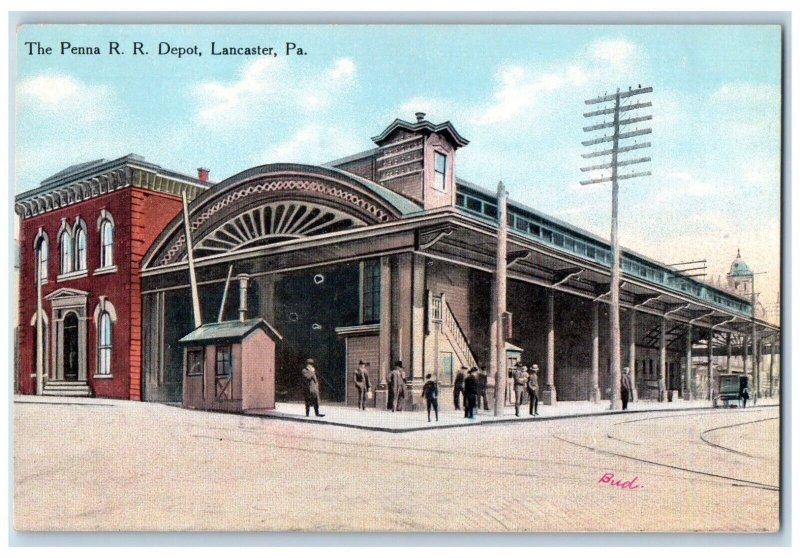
[19,188,181,399]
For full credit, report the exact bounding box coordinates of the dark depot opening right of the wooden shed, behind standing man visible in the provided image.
[275,263,359,401]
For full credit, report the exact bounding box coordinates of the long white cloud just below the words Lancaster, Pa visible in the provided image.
[193,57,356,127]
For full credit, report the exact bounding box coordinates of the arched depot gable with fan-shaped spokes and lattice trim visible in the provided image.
[143,163,421,269]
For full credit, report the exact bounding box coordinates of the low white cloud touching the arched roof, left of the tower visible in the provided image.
[255,124,360,168]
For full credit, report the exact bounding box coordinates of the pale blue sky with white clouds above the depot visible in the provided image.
[15,25,781,310]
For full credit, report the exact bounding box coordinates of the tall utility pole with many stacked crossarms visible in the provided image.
[581,86,653,409]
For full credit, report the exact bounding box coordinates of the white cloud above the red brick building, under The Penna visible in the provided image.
[17,73,114,123]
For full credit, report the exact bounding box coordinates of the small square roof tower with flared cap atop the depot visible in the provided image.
[372,112,469,209]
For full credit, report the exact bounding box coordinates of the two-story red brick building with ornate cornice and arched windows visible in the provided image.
[15,158,209,400]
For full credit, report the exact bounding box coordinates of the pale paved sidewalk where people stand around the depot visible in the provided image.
[248,398,779,432]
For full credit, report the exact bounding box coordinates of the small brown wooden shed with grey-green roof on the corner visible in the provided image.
[180,318,282,412]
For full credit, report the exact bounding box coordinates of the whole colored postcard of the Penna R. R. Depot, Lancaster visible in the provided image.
[9,24,784,533]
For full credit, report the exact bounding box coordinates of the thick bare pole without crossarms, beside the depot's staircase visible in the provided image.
[493,181,508,417]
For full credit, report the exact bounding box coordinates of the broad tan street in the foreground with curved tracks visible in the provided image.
[14,398,780,532]
